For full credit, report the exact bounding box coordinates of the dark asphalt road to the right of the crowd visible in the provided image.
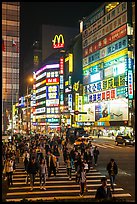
[94,138,135,202]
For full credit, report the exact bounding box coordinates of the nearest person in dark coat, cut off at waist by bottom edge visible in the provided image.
[95,177,112,201]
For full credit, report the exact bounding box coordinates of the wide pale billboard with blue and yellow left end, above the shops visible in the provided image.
[95,98,128,122]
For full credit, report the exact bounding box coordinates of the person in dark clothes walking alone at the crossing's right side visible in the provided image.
[107,159,118,191]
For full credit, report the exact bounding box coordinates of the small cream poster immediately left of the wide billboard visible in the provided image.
[83,103,95,122]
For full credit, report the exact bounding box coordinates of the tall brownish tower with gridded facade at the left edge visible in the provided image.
[2,2,20,132]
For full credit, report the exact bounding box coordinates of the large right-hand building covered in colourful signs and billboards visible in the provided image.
[82,2,134,135]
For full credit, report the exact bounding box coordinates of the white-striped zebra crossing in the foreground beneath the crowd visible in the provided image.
[6,159,131,202]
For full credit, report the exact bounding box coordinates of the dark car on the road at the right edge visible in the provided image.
[115,135,135,146]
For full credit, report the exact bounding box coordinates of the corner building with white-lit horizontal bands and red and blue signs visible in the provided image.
[32,52,64,132]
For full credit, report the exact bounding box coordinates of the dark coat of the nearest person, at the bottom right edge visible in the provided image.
[95,186,112,199]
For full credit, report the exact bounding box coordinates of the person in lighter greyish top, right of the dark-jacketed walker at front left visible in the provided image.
[39,158,48,190]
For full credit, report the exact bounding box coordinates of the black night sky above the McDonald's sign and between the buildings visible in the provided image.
[20,2,103,96]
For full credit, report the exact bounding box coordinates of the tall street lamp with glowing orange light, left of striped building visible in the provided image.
[27,77,34,134]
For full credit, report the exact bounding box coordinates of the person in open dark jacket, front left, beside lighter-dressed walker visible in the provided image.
[27,157,39,191]
